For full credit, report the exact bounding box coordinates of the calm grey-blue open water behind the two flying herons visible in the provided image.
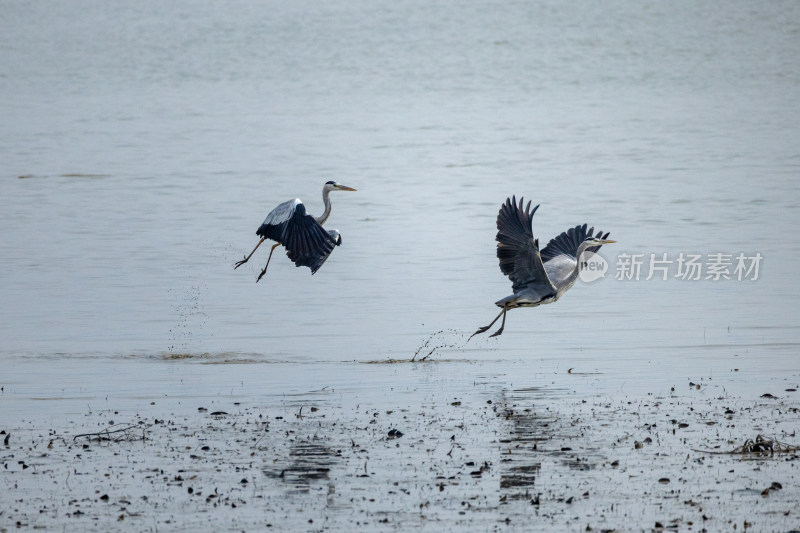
[0,1,800,409]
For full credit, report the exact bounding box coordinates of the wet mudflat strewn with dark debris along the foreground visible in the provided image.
[0,387,800,531]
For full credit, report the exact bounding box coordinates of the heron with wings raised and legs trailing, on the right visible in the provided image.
[468,196,616,340]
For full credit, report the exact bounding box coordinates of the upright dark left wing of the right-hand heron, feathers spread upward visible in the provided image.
[496,196,556,296]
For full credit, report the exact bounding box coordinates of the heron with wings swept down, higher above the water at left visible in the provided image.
[233,181,356,283]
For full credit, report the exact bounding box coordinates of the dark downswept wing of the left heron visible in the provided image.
[280,203,336,274]
